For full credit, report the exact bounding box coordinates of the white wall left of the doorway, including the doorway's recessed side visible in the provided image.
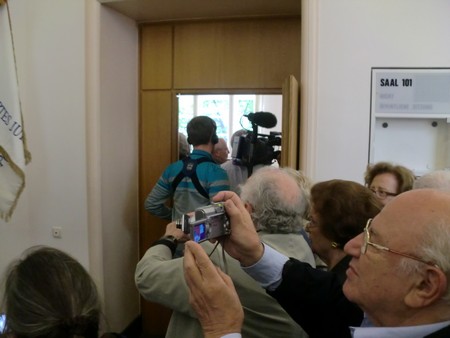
[0,0,139,331]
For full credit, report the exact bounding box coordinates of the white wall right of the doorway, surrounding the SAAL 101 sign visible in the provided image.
[301,0,450,182]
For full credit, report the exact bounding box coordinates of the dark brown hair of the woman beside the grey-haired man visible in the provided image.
[311,180,382,248]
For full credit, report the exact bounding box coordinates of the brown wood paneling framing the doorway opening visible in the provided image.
[139,16,300,335]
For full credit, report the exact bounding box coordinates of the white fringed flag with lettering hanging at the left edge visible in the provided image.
[0,0,31,221]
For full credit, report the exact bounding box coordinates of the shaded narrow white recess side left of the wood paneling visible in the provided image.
[100,3,139,331]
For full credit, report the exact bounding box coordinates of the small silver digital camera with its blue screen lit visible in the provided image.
[177,203,231,242]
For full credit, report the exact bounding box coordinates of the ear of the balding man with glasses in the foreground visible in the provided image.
[405,266,447,308]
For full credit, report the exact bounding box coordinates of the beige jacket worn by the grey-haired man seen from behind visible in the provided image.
[135,234,314,338]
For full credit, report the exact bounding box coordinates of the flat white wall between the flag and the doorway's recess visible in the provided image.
[0,0,89,271]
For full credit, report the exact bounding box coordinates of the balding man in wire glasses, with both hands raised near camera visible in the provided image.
[185,189,450,338]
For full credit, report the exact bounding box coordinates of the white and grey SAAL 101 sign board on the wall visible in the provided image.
[369,68,450,176]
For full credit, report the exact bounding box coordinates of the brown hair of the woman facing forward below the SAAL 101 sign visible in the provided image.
[364,162,415,194]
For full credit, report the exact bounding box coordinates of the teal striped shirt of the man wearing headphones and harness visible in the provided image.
[144,149,230,220]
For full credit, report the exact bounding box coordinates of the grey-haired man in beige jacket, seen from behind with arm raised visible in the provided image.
[135,167,315,338]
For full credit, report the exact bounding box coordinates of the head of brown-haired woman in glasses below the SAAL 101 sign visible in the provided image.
[364,162,415,205]
